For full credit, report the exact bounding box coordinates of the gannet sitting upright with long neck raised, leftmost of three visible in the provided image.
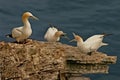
[6,12,38,42]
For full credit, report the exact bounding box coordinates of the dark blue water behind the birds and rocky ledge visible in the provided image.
[0,0,120,80]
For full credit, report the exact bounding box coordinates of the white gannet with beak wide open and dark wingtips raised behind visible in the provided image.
[71,33,110,53]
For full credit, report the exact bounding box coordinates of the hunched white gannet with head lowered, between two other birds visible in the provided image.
[44,27,66,42]
